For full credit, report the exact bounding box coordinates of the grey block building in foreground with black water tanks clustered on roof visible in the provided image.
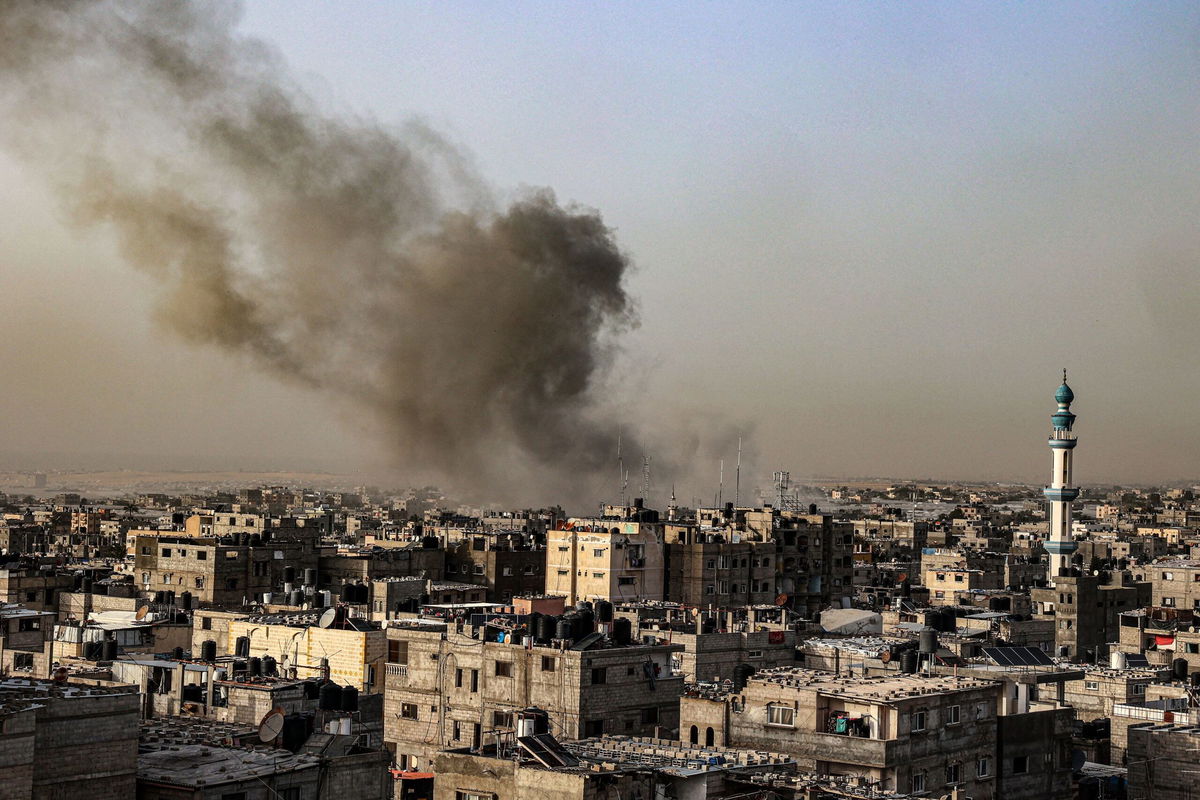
[384,620,683,769]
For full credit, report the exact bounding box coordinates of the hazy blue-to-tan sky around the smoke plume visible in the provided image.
[0,0,1200,499]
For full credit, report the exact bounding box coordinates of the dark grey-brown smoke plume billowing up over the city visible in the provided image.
[0,0,635,501]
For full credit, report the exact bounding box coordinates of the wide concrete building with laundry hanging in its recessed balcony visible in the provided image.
[680,668,1001,799]
